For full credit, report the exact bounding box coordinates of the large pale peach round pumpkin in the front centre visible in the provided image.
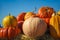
[23,17,47,38]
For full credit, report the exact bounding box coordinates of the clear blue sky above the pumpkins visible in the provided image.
[0,0,60,24]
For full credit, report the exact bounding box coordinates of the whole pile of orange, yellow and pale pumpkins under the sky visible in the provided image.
[0,7,60,39]
